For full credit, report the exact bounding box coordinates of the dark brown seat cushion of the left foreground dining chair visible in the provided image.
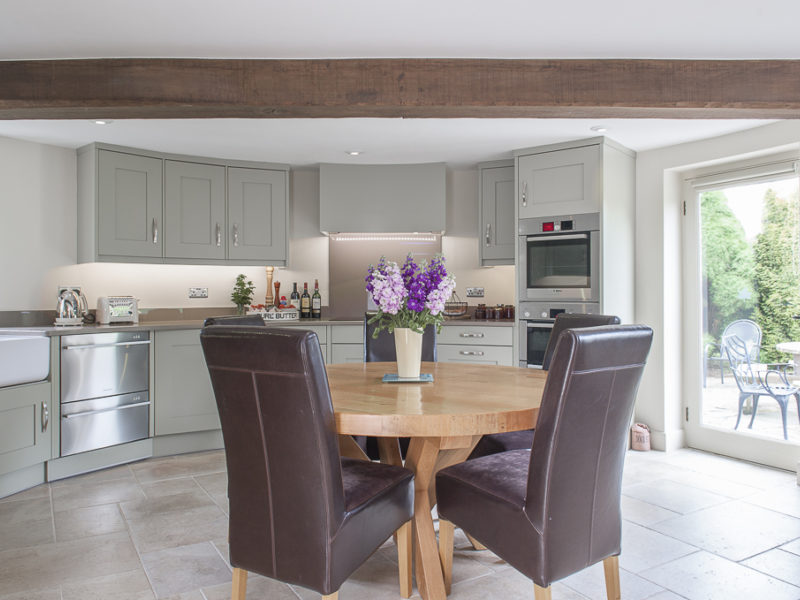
[342,458,414,512]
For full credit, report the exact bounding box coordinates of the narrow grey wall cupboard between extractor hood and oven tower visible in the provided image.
[478,161,517,267]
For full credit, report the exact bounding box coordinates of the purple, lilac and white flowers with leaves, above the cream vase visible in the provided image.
[365,254,456,337]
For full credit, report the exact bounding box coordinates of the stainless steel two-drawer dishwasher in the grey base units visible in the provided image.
[61,331,150,456]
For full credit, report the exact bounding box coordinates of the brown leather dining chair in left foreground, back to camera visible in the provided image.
[200,325,414,600]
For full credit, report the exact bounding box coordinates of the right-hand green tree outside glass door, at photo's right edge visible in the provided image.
[755,189,800,362]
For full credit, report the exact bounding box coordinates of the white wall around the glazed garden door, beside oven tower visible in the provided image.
[635,121,800,449]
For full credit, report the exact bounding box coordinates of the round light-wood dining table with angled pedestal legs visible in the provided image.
[326,362,546,600]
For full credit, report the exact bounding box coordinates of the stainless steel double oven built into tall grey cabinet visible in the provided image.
[518,213,600,369]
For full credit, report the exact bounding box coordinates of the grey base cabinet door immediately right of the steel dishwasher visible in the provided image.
[153,329,220,436]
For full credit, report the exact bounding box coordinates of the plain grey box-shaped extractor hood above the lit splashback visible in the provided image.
[319,163,445,233]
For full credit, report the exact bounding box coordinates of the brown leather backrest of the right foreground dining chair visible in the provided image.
[525,325,653,581]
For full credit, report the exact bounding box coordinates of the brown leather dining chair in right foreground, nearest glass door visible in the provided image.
[436,325,653,600]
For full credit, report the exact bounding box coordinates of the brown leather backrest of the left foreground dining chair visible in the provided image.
[200,325,344,589]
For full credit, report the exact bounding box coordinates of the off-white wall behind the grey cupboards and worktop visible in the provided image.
[0,138,514,310]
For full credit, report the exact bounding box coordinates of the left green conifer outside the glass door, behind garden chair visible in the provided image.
[700,191,755,341]
